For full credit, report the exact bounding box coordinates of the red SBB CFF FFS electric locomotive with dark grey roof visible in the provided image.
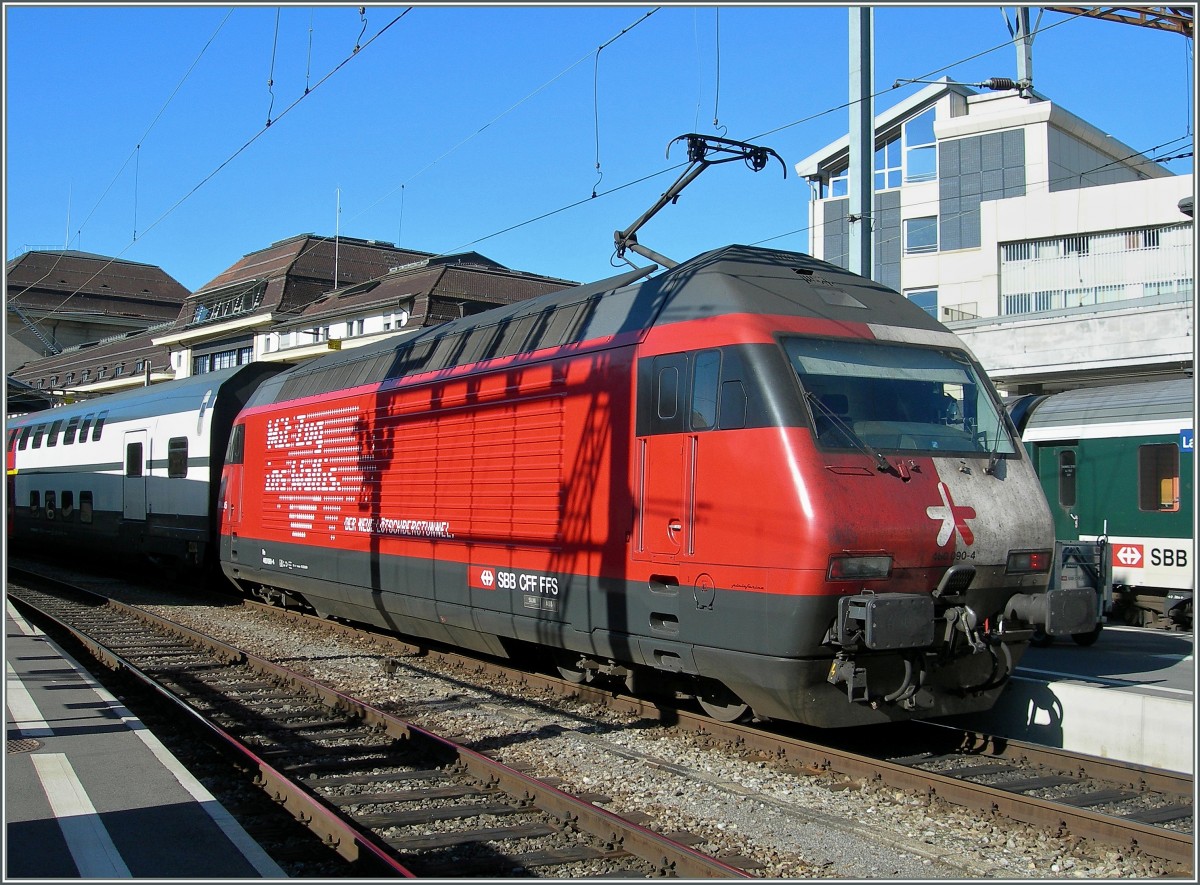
[218,246,1094,727]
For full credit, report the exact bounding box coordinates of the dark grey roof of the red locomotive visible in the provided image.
[258,246,946,405]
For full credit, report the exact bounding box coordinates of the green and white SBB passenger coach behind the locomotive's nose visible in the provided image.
[1009,379,1196,627]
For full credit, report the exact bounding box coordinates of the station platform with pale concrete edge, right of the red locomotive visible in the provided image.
[948,626,1196,775]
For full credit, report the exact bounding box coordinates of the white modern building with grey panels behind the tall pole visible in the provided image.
[796,80,1195,392]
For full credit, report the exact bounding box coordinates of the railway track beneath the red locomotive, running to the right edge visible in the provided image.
[7,561,1193,875]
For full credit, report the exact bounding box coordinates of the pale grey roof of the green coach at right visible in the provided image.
[1024,378,1194,439]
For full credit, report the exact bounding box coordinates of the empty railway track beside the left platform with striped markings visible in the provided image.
[8,574,748,878]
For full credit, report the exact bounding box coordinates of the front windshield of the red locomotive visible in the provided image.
[784,338,1016,457]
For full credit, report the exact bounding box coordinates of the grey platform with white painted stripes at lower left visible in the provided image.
[4,603,286,881]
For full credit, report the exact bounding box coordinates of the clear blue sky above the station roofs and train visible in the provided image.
[4,4,1194,290]
